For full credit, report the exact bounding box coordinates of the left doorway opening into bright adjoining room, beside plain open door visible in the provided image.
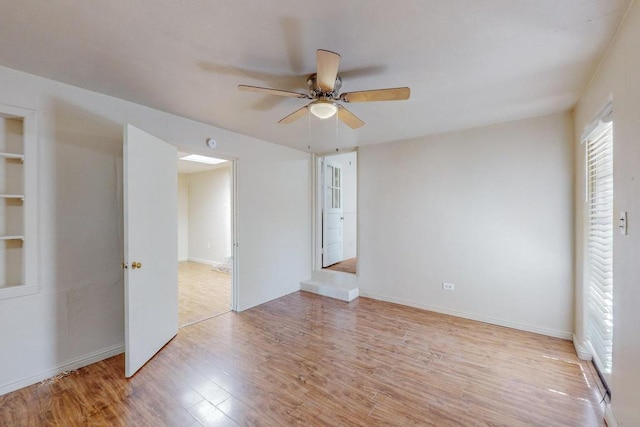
[178,152,233,327]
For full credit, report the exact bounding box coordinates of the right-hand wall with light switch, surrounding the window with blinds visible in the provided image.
[575,2,640,426]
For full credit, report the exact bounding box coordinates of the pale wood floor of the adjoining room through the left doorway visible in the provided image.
[178,261,231,326]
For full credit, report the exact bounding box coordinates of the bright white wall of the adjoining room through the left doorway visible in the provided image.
[189,163,231,267]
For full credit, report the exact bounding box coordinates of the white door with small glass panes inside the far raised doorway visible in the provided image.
[322,159,344,267]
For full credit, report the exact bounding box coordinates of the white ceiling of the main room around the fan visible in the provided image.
[0,0,629,151]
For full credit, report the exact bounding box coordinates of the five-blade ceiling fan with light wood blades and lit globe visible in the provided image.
[238,49,411,129]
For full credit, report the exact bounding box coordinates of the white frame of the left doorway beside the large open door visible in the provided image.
[176,145,240,312]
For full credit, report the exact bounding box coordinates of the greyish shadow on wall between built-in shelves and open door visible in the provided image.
[47,99,124,368]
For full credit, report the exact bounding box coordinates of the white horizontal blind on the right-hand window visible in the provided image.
[586,121,613,378]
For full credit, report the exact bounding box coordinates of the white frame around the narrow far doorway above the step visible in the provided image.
[311,148,360,275]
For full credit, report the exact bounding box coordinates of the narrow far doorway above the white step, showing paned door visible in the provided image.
[316,151,358,274]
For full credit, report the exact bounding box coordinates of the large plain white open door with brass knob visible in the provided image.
[123,125,178,377]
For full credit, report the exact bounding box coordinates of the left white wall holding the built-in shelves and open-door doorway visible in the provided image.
[0,67,311,394]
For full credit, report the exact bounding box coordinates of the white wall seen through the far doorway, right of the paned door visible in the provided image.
[327,151,358,259]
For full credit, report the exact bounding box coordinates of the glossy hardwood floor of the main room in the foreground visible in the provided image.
[0,292,604,427]
